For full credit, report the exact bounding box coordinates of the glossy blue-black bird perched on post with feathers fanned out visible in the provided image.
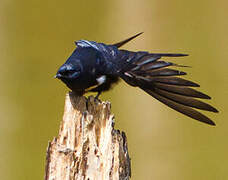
[55,33,218,125]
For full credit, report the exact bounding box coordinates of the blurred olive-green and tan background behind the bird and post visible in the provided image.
[0,0,228,180]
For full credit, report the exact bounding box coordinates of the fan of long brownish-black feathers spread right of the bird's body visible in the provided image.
[121,51,218,125]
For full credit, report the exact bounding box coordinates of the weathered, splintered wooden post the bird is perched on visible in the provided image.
[45,93,131,180]
